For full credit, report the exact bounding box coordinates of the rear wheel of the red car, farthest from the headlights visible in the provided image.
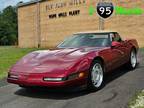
[127,49,137,70]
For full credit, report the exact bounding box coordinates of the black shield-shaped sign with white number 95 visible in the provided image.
[97,2,114,18]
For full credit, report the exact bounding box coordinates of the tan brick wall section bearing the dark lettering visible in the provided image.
[40,0,98,47]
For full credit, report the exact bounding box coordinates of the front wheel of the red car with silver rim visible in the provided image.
[87,60,104,91]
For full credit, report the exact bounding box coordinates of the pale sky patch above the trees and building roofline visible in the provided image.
[0,0,30,11]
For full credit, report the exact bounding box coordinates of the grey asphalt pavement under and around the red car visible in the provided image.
[0,52,144,108]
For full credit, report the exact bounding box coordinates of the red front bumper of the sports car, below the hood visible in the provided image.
[7,74,87,87]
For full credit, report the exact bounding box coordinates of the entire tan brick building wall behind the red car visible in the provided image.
[18,0,144,47]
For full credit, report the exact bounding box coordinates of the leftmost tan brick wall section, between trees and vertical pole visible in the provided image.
[18,5,37,47]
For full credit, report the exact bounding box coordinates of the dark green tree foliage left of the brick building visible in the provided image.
[0,6,18,45]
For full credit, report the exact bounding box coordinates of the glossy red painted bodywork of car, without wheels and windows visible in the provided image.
[7,33,138,87]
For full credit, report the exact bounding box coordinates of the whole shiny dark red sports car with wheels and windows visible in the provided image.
[7,32,139,90]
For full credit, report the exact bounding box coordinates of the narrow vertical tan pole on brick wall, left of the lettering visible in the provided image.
[36,0,41,48]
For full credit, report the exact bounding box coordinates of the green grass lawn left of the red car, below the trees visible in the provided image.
[0,46,43,79]
